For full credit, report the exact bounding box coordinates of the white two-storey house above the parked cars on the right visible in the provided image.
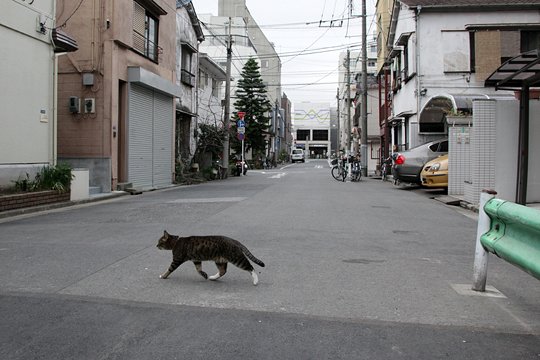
[387,0,540,149]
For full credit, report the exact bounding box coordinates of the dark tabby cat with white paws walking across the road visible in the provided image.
[157,231,264,285]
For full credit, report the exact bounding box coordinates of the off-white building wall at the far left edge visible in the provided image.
[0,0,77,187]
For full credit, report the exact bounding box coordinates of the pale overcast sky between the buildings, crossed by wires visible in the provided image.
[192,0,376,106]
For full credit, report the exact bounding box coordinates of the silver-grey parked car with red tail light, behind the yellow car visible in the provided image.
[392,139,448,185]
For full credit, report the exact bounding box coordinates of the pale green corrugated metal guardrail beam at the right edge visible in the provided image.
[480,198,540,280]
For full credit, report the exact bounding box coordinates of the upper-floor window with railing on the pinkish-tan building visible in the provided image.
[133,1,159,62]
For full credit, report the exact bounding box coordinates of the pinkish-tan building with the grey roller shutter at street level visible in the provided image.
[56,0,197,192]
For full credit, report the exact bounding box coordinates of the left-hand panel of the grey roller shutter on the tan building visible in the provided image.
[128,84,154,187]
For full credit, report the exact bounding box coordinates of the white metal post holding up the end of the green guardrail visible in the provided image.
[472,189,497,292]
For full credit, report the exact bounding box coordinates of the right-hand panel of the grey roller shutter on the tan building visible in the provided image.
[153,92,173,186]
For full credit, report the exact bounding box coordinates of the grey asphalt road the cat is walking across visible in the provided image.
[0,161,540,360]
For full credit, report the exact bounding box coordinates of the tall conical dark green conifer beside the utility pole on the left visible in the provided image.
[231,58,272,157]
